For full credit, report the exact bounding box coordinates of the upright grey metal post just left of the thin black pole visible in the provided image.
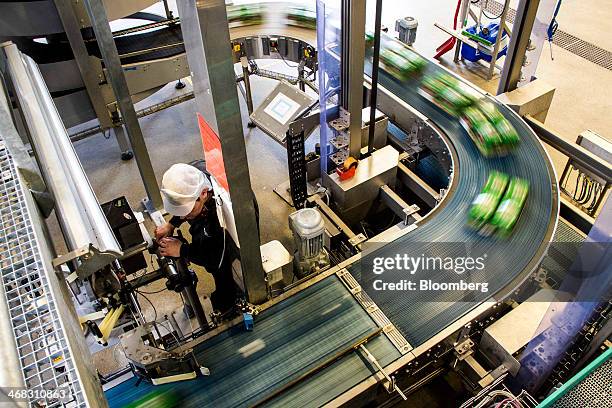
[341,0,366,158]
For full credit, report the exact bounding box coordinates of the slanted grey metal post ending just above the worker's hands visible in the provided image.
[84,0,162,210]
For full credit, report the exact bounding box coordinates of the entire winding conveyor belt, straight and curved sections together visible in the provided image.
[3,3,558,406]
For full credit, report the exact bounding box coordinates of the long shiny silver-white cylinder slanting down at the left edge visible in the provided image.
[2,43,121,274]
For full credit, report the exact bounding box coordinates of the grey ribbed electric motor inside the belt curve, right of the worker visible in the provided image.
[289,208,329,278]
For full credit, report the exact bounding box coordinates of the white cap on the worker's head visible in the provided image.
[161,163,212,217]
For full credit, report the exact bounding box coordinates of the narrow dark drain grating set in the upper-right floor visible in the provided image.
[480,0,612,71]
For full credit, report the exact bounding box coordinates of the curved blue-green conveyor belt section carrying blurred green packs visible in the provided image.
[349,36,558,347]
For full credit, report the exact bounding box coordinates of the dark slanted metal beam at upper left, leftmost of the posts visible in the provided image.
[54,0,112,130]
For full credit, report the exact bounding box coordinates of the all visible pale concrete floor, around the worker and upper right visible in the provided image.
[52,0,612,388]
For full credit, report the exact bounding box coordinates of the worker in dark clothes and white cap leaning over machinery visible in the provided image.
[155,161,239,315]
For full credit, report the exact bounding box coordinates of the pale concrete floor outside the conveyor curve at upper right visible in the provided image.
[396,0,612,175]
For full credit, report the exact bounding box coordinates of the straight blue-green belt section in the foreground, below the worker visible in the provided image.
[106,275,400,407]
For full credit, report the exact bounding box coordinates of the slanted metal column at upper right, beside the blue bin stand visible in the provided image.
[497,0,540,95]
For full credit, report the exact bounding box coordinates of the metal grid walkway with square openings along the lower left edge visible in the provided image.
[0,139,85,407]
